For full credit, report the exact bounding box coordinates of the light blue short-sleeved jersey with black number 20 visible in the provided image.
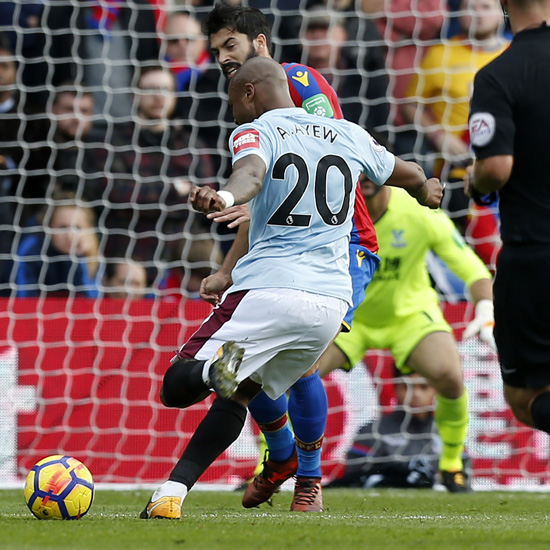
[229,108,395,303]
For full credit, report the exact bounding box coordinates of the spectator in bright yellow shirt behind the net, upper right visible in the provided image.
[403,0,509,244]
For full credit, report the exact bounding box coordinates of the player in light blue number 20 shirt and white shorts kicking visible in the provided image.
[140,58,442,519]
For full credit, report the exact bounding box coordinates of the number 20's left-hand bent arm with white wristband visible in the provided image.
[189,154,266,217]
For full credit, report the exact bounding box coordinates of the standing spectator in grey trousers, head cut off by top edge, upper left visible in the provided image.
[37,0,160,124]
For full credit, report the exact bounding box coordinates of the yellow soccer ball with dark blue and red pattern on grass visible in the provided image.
[25,455,94,519]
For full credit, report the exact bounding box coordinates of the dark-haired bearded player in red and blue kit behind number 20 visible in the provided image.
[203,3,379,511]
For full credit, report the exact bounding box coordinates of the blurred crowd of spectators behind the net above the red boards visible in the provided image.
[0,0,508,298]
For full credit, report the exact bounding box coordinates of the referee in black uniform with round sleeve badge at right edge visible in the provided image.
[466,0,550,433]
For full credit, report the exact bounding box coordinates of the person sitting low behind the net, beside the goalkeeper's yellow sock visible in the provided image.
[327,369,441,489]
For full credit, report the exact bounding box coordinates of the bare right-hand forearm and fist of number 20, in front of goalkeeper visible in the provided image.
[386,157,443,208]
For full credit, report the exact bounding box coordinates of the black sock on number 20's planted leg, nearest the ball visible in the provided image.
[170,397,246,489]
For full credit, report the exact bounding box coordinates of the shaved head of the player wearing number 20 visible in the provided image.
[229,57,295,124]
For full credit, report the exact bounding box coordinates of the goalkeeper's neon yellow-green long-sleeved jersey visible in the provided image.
[354,187,491,327]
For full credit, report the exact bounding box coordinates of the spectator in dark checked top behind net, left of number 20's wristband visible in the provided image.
[92,66,213,286]
